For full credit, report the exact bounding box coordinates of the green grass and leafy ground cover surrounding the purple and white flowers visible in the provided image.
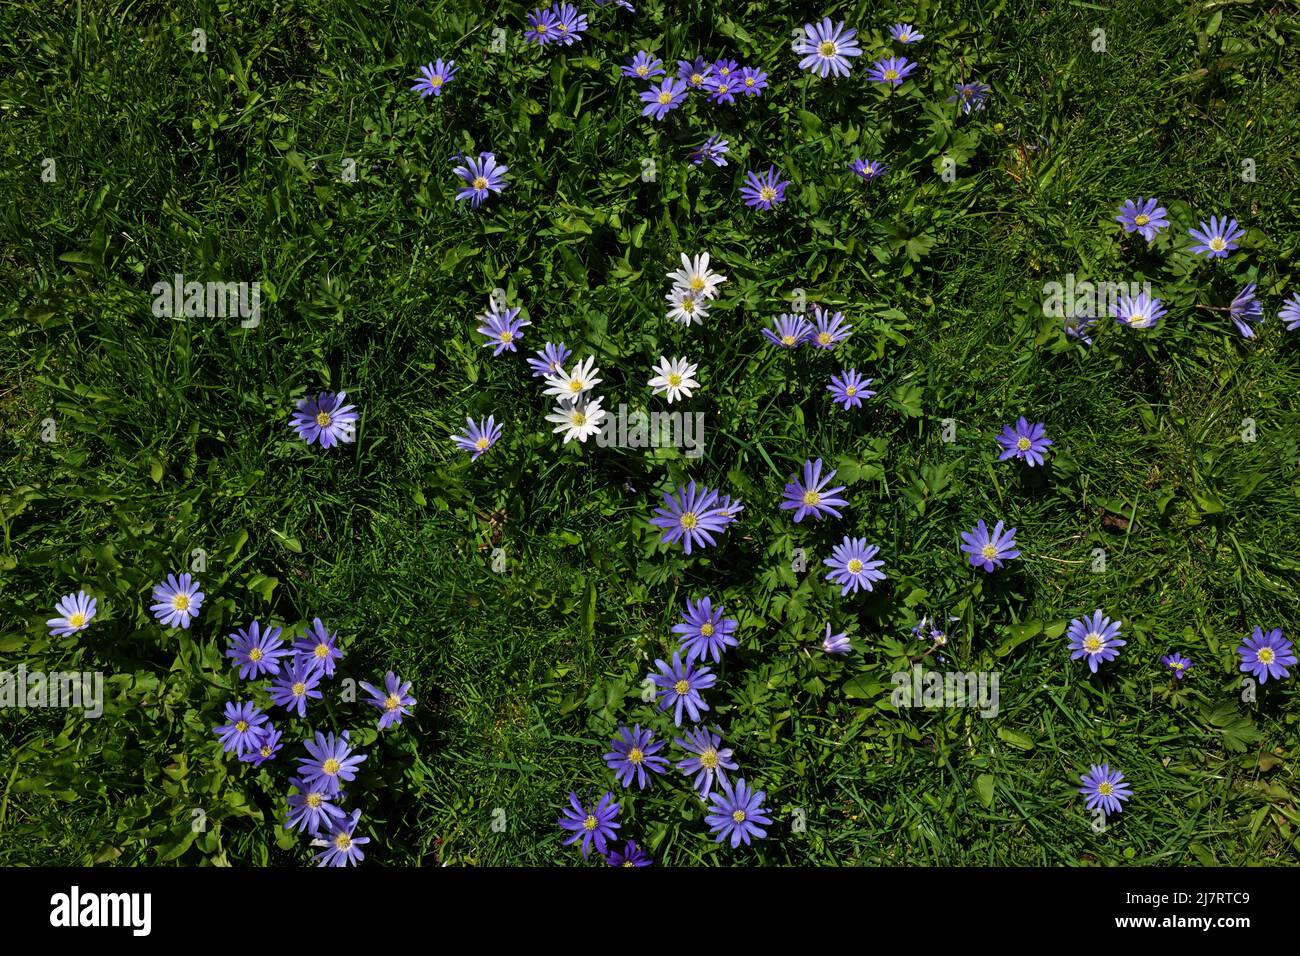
[0,0,1300,865]
